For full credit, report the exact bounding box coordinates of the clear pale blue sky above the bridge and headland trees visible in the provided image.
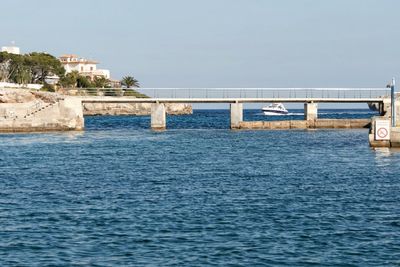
[0,0,400,87]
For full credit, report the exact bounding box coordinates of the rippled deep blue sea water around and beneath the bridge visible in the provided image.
[0,110,400,266]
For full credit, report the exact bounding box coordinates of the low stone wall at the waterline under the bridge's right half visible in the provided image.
[236,119,371,130]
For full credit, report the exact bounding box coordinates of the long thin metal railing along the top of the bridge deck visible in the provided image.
[68,88,390,99]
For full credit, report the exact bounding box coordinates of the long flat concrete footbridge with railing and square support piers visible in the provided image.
[78,88,390,130]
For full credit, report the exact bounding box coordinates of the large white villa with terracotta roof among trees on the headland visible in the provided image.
[59,55,110,80]
